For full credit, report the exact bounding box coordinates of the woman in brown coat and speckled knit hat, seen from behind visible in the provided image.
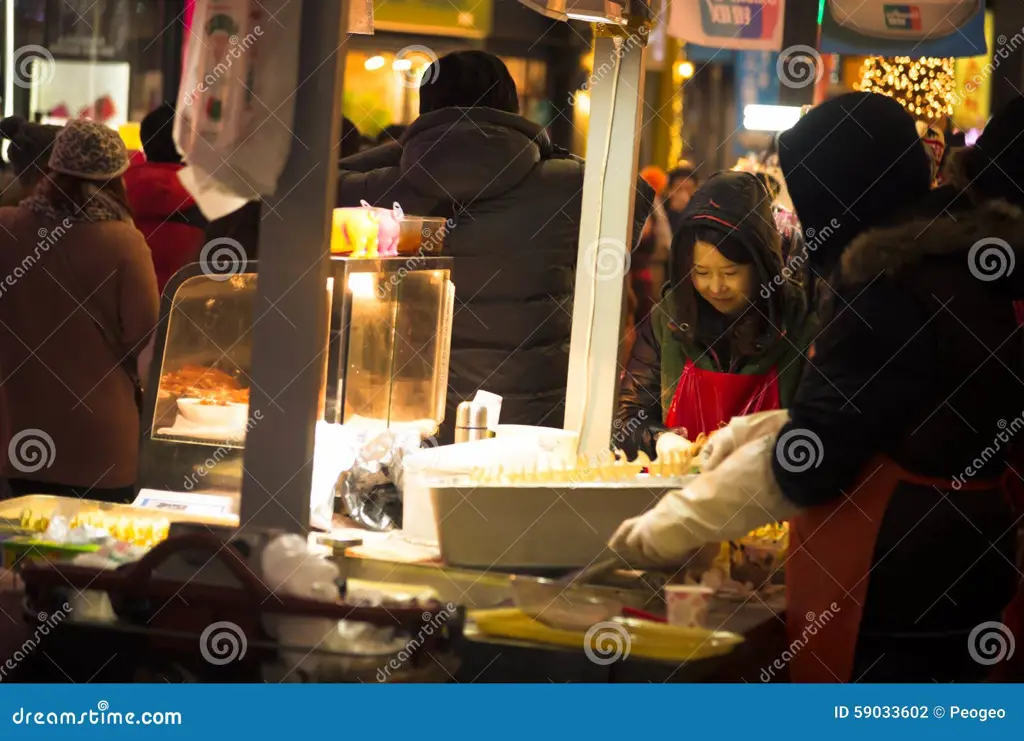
[0,120,159,503]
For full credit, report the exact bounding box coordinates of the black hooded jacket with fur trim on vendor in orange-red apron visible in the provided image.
[772,94,1024,682]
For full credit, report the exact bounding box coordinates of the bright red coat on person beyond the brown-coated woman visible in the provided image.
[125,162,206,292]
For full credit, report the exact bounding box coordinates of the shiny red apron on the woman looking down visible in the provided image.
[665,360,779,440]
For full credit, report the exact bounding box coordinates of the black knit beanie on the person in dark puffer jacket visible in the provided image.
[420,49,519,115]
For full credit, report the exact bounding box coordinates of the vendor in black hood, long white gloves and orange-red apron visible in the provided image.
[612,93,1024,682]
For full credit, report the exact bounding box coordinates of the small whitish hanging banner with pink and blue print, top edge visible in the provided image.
[668,0,785,51]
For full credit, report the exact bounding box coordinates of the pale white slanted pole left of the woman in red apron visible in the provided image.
[565,35,645,455]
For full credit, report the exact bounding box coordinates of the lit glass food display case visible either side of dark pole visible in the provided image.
[139,256,455,496]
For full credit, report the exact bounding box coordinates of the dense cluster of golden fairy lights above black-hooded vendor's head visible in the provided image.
[857,56,956,123]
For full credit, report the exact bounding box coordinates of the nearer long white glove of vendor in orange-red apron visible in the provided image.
[608,434,799,566]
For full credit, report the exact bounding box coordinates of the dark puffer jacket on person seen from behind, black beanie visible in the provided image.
[338,107,647,442]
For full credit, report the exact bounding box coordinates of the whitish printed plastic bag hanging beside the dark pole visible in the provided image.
[174,0,302,220]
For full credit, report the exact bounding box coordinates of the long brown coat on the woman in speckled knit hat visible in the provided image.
[0,207,159,488]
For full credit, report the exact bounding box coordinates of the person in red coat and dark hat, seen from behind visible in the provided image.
[125,103,206,293]
